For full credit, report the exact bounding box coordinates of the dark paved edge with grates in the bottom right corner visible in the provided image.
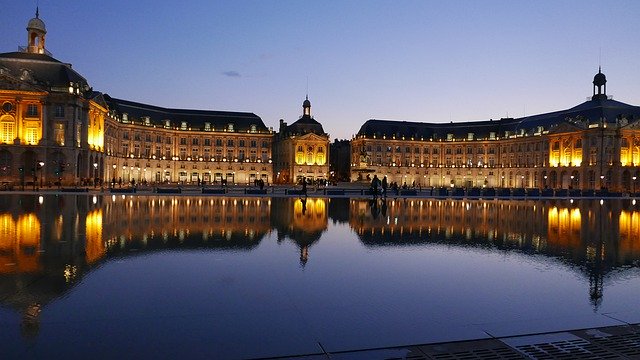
[282,324,640,360]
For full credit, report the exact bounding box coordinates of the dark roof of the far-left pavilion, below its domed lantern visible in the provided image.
[0,52,87,91]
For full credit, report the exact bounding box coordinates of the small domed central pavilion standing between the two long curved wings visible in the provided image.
[273,96,329,183]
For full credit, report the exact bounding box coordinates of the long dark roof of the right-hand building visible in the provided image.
[358,99,640,139]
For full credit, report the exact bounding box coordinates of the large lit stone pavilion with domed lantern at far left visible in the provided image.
[0,11,107,187]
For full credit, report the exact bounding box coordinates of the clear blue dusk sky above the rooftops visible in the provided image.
[0,0,640,140]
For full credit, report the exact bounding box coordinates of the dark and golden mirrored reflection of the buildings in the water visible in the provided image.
[0,195,640,336]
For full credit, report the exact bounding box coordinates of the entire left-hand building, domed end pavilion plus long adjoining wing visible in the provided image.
[0,10,273,188]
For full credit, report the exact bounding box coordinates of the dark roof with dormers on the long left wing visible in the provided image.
[104,94,269,133]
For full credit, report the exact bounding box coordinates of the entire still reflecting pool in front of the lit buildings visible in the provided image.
[0,195,640,358]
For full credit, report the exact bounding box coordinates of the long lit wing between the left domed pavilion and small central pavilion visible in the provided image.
[105,95,273,184]
